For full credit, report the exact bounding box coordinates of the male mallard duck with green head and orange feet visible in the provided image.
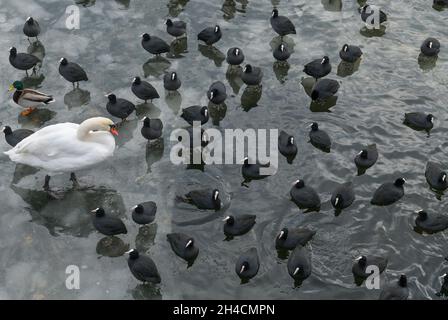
[9,81,54,116]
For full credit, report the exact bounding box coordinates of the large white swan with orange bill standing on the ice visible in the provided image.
[5,117,118,190]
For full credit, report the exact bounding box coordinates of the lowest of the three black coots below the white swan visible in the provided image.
[128,249,161,284]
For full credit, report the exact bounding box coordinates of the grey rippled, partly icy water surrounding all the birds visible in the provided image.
[0,0,448,299]
